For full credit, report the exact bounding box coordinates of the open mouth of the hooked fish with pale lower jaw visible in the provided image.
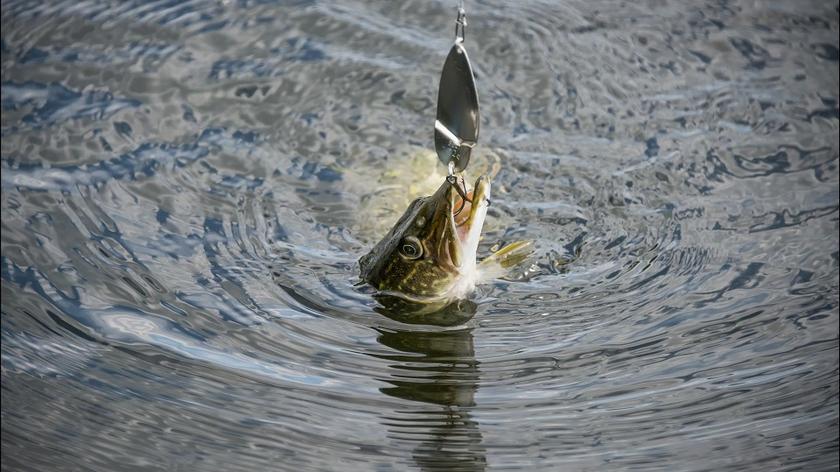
[448,175,490,271]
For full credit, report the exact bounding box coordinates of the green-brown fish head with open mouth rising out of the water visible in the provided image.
[359,176,490,304]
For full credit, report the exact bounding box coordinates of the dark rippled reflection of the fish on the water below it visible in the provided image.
[377,301,487,471]
